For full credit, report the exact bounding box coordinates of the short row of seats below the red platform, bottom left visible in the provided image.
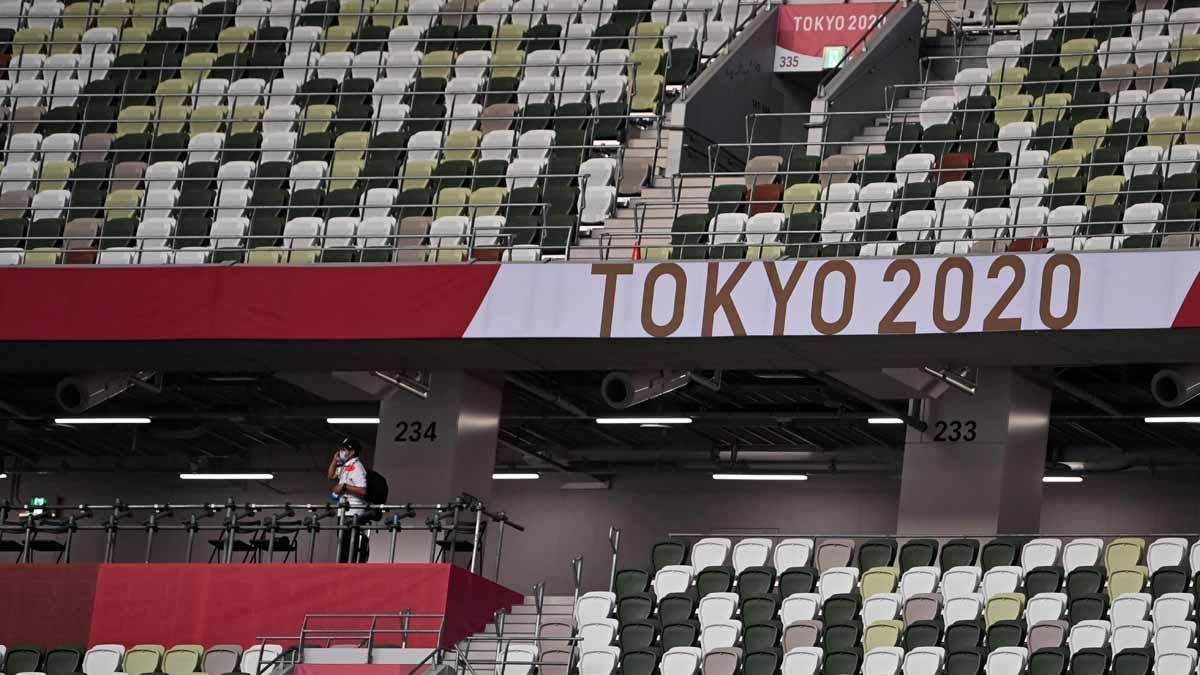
[0,644,283,675]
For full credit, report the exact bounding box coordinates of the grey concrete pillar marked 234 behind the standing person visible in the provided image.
[371,371,503,565]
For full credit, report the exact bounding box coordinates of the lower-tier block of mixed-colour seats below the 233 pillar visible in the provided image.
[561,537,1200,675]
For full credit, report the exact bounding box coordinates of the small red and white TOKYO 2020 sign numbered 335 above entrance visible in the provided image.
[775,2,892,72]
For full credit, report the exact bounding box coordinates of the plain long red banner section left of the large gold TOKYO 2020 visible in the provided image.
[0,265,499,340]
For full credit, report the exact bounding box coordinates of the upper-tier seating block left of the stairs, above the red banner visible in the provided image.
[0,0,756,264]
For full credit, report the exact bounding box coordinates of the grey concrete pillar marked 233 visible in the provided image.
[896,369,1050,534]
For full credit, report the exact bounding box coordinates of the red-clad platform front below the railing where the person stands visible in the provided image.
[0,565,521,647]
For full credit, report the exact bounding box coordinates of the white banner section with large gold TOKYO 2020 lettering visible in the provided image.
[464,251,1200,338]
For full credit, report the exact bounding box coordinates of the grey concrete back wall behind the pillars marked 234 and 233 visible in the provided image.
[9,468,1200,593]
